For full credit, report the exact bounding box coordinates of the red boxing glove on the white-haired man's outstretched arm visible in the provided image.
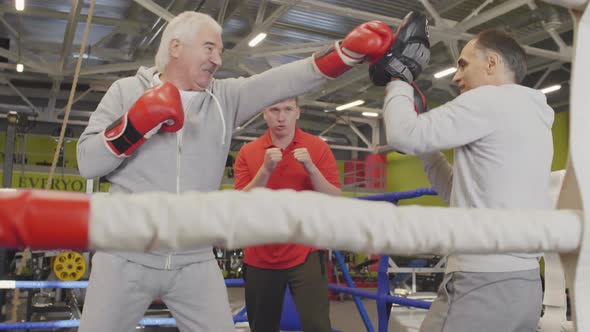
[314,21,393,78]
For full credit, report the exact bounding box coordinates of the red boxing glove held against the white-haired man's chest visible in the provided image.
[104,82,184,157]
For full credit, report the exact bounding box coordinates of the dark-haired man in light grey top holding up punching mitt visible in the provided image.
[372,26,554,332]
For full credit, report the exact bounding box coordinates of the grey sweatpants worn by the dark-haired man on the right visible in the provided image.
[420,269,543,332]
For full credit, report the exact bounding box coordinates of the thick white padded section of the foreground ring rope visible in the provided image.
[90,189,581,254]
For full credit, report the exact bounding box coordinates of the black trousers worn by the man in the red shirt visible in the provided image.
[244,251,332,332]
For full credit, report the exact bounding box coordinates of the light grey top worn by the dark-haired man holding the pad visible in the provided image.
[384,81,555,272]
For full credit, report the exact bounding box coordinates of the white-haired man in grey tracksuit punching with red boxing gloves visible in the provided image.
[77,12,393,332]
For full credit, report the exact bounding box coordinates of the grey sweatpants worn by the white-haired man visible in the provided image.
[78,252,235,332]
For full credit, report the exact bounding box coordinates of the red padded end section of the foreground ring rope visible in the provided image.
[0,191,90,250]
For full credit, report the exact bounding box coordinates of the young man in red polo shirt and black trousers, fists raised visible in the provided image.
[234,98,341,332]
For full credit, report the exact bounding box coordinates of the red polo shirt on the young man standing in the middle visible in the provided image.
[234,127,340,270]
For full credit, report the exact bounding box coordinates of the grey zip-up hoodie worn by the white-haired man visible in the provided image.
[77,58,326,269]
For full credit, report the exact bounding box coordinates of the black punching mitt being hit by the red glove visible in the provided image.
[369,12,430,86]
